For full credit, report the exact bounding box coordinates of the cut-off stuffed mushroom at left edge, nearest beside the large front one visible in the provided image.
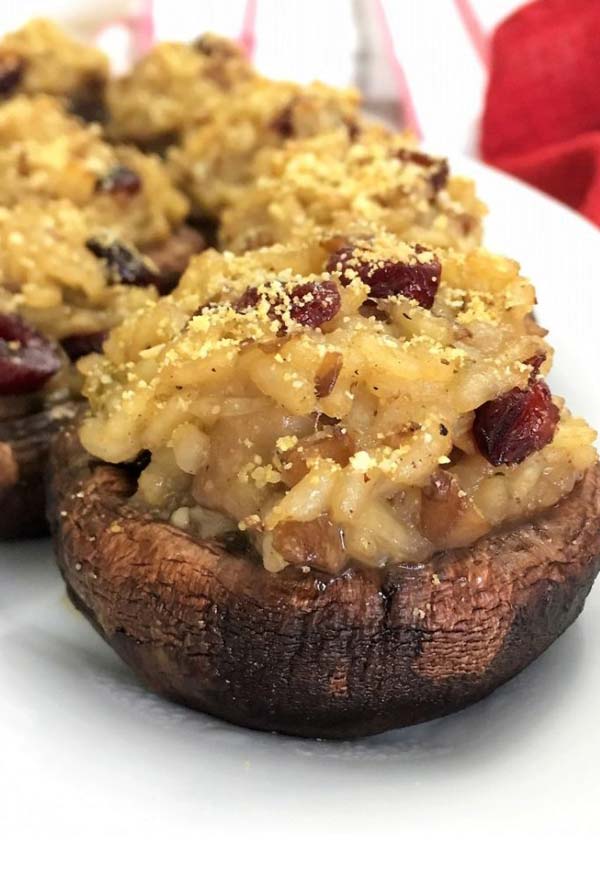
[0,194,204,539]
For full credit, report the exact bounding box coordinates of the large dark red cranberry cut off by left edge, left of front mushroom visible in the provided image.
[0,314,60,395]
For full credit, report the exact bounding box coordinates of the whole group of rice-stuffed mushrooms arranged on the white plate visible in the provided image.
[0,22,600,738]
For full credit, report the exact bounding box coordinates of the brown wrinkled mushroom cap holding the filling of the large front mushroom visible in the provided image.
[49,426,600,738]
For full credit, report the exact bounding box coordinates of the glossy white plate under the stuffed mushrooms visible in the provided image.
[0,160,600,871]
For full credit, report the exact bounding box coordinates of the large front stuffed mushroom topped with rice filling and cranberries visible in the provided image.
[50,232,600,737]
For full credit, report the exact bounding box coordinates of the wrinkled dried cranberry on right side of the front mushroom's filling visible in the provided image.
[473,379,560,467]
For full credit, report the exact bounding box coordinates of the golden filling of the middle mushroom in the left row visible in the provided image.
[0,95,189,246]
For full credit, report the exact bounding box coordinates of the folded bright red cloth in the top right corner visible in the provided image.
[481,0,600,225]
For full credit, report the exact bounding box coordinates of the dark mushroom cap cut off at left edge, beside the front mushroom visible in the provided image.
[0,397,78,541]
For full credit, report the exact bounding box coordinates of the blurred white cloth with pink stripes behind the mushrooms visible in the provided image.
[0,0,518,152]
